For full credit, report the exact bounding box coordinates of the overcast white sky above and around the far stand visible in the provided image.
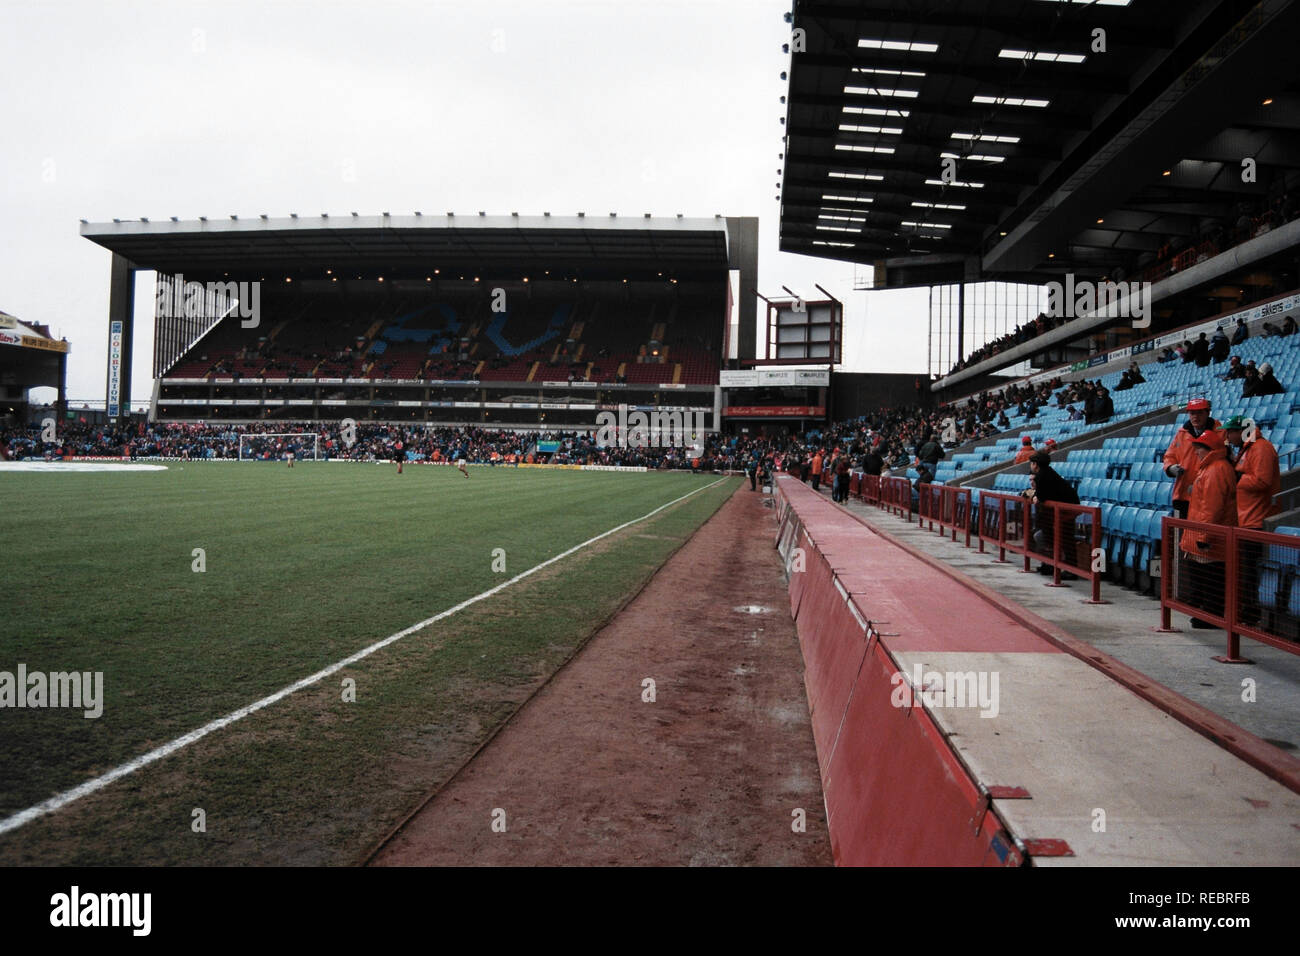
[0,0,927,401]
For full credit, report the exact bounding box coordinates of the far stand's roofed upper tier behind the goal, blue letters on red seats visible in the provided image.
[81,212,758,431]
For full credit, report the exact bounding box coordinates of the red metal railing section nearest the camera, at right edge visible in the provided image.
[1160,518,1300,663]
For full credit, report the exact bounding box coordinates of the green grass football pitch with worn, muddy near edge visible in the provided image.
[0,462,738,865]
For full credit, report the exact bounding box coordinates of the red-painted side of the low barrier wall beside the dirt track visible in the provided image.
[776,479,1024,866]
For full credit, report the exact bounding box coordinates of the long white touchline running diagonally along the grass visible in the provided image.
[0,479,727,834]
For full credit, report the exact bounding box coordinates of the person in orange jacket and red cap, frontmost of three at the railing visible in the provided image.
[1178,429,1236,628]
